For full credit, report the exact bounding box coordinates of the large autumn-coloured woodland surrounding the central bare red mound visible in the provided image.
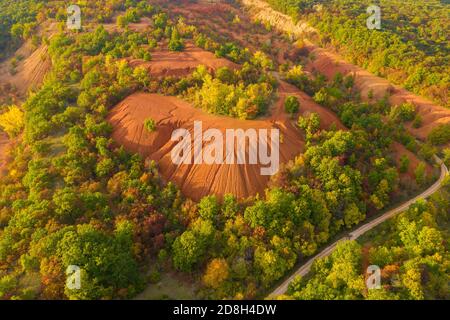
[0,0,450,299]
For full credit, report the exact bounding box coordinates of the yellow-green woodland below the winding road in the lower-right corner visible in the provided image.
[288,178,450,300]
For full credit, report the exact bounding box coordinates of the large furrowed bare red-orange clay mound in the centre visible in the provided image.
[108,93,304,200]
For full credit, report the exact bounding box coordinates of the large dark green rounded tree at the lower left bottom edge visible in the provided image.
[57,222,142,299]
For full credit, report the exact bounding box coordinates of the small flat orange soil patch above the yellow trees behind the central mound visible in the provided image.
[129,43,238,77]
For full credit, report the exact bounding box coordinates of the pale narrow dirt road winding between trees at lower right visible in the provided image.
[268,156,448,298]
